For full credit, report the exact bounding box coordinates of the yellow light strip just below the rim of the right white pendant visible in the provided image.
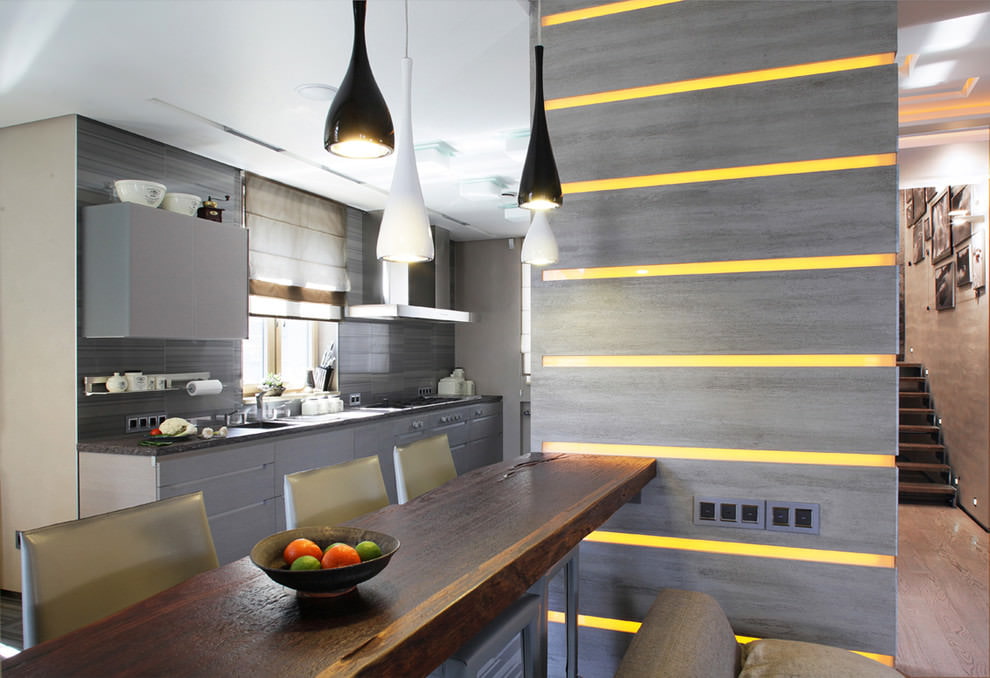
[543,254,897,282]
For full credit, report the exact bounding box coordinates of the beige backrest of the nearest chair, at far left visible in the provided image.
[20,492,219,648]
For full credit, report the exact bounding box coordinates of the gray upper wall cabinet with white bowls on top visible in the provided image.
[81,203,248,339]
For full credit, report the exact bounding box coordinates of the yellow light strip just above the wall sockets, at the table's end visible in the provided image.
[541,441,896,468]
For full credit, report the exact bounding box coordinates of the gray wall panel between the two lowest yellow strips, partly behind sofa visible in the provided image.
[551,542,897,655]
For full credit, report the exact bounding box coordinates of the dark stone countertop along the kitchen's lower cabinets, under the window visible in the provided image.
[76,396,502,457]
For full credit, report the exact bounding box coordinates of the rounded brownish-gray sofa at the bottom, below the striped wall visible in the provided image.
[615,589,902,678]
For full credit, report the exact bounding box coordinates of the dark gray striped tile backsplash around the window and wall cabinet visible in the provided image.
[77,117,454,440]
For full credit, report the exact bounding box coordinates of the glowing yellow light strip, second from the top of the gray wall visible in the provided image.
[546,52,894,111]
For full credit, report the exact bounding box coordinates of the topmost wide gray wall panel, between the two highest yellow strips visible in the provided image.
[543,0,897,98]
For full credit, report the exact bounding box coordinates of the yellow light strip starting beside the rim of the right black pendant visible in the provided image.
[562,153,897,195]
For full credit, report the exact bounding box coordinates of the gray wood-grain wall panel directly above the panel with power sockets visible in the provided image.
[532,367,897,454]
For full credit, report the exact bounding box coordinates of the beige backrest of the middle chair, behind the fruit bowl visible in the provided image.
[283,455,388,529]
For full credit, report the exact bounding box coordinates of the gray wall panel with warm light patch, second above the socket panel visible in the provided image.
[533,266,897,355]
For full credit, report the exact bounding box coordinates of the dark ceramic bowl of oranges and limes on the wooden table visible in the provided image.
[251,527,399,595]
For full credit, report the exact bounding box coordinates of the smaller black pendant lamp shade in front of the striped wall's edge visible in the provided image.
[518,45,564,210]
